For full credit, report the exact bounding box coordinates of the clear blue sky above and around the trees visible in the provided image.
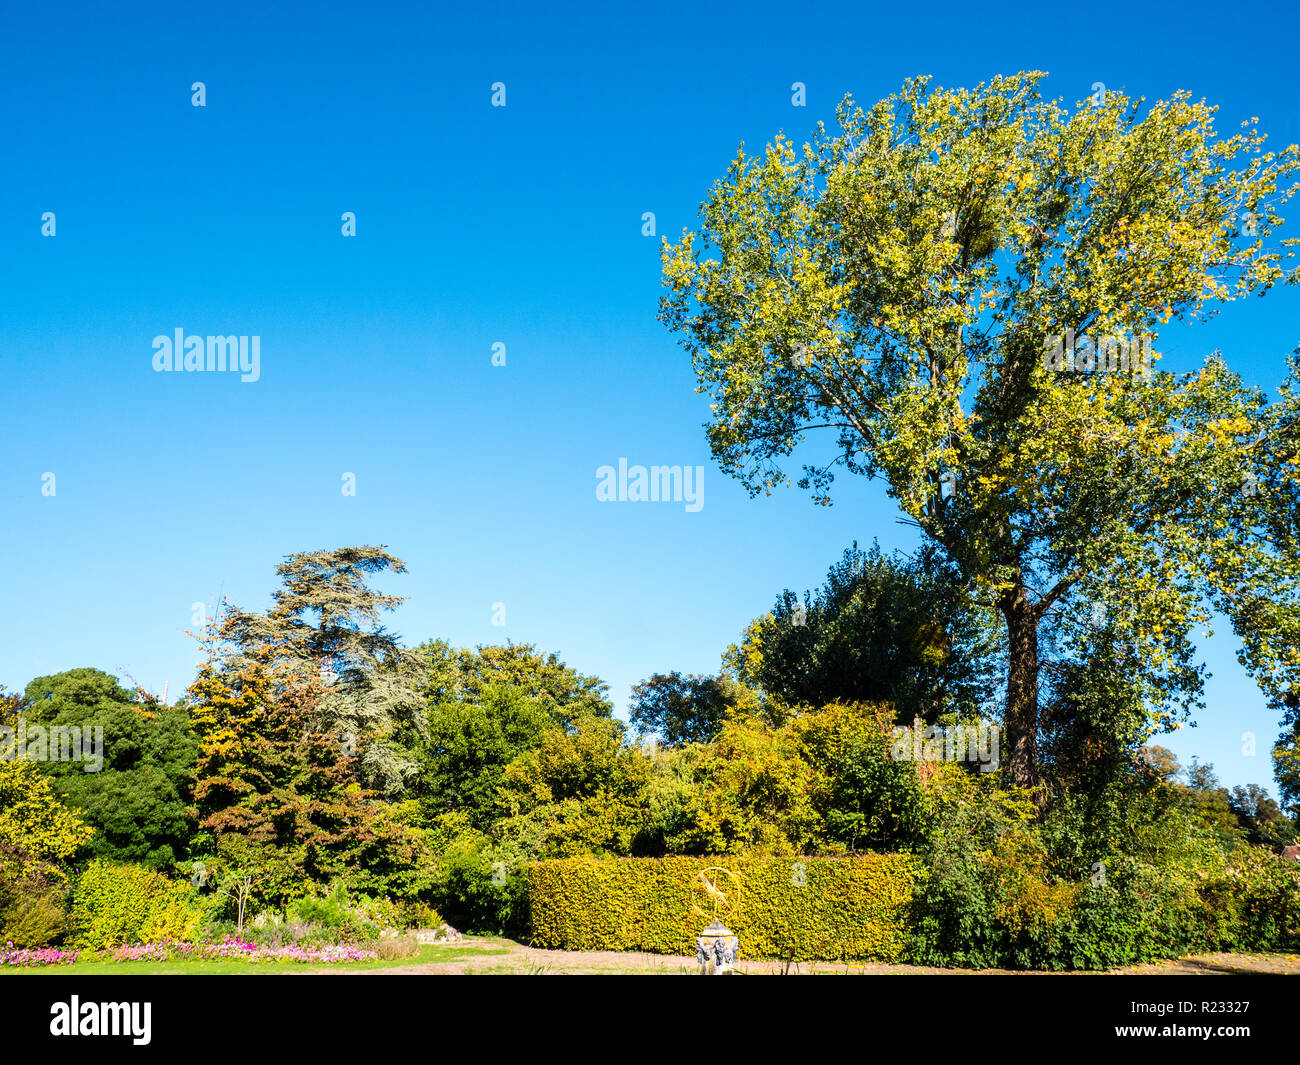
[0,3,1300,801]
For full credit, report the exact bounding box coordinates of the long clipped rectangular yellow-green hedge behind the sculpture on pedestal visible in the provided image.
[528,854,915,961]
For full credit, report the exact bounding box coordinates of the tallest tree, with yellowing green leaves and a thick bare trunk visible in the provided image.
[660,73,1300,787]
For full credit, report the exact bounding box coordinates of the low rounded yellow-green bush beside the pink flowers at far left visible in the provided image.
[72,862,199,949]
